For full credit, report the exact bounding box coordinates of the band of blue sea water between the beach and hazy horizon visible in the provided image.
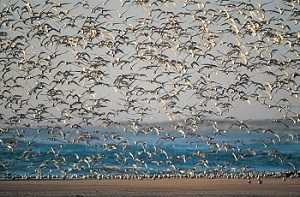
[0,128,300,179]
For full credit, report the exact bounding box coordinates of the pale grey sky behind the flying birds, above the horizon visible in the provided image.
[0,0,300,125]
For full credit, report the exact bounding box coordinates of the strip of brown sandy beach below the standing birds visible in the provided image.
[0,178,300,197]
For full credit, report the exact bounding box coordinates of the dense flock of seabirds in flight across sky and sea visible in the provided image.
[0,0,300,181]
